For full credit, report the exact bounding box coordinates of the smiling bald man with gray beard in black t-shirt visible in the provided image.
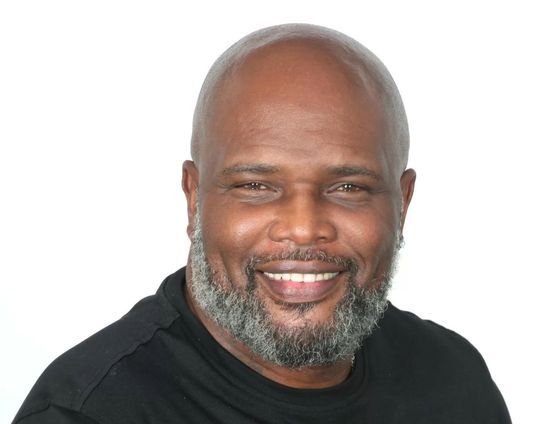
[14,25,510,424]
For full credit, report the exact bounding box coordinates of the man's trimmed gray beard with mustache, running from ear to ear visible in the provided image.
[188,211,399,369]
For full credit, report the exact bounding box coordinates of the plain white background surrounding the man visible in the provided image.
[0,0,550,423]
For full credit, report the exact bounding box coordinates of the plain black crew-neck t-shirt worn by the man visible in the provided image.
[14,269,511,424]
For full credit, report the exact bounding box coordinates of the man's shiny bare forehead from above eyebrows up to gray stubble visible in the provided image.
[201,44,398,179]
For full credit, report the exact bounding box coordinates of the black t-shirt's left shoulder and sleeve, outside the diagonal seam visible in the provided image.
[14,270,185,423]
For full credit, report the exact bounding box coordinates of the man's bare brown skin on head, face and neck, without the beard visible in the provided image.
[182,25,415,388]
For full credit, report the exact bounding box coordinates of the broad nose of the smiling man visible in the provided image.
[269,191,336,247]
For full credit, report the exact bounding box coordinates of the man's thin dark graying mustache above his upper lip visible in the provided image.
[246,249,359,276]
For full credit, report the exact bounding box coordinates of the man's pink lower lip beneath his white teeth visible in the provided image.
[257,272,342,303]
